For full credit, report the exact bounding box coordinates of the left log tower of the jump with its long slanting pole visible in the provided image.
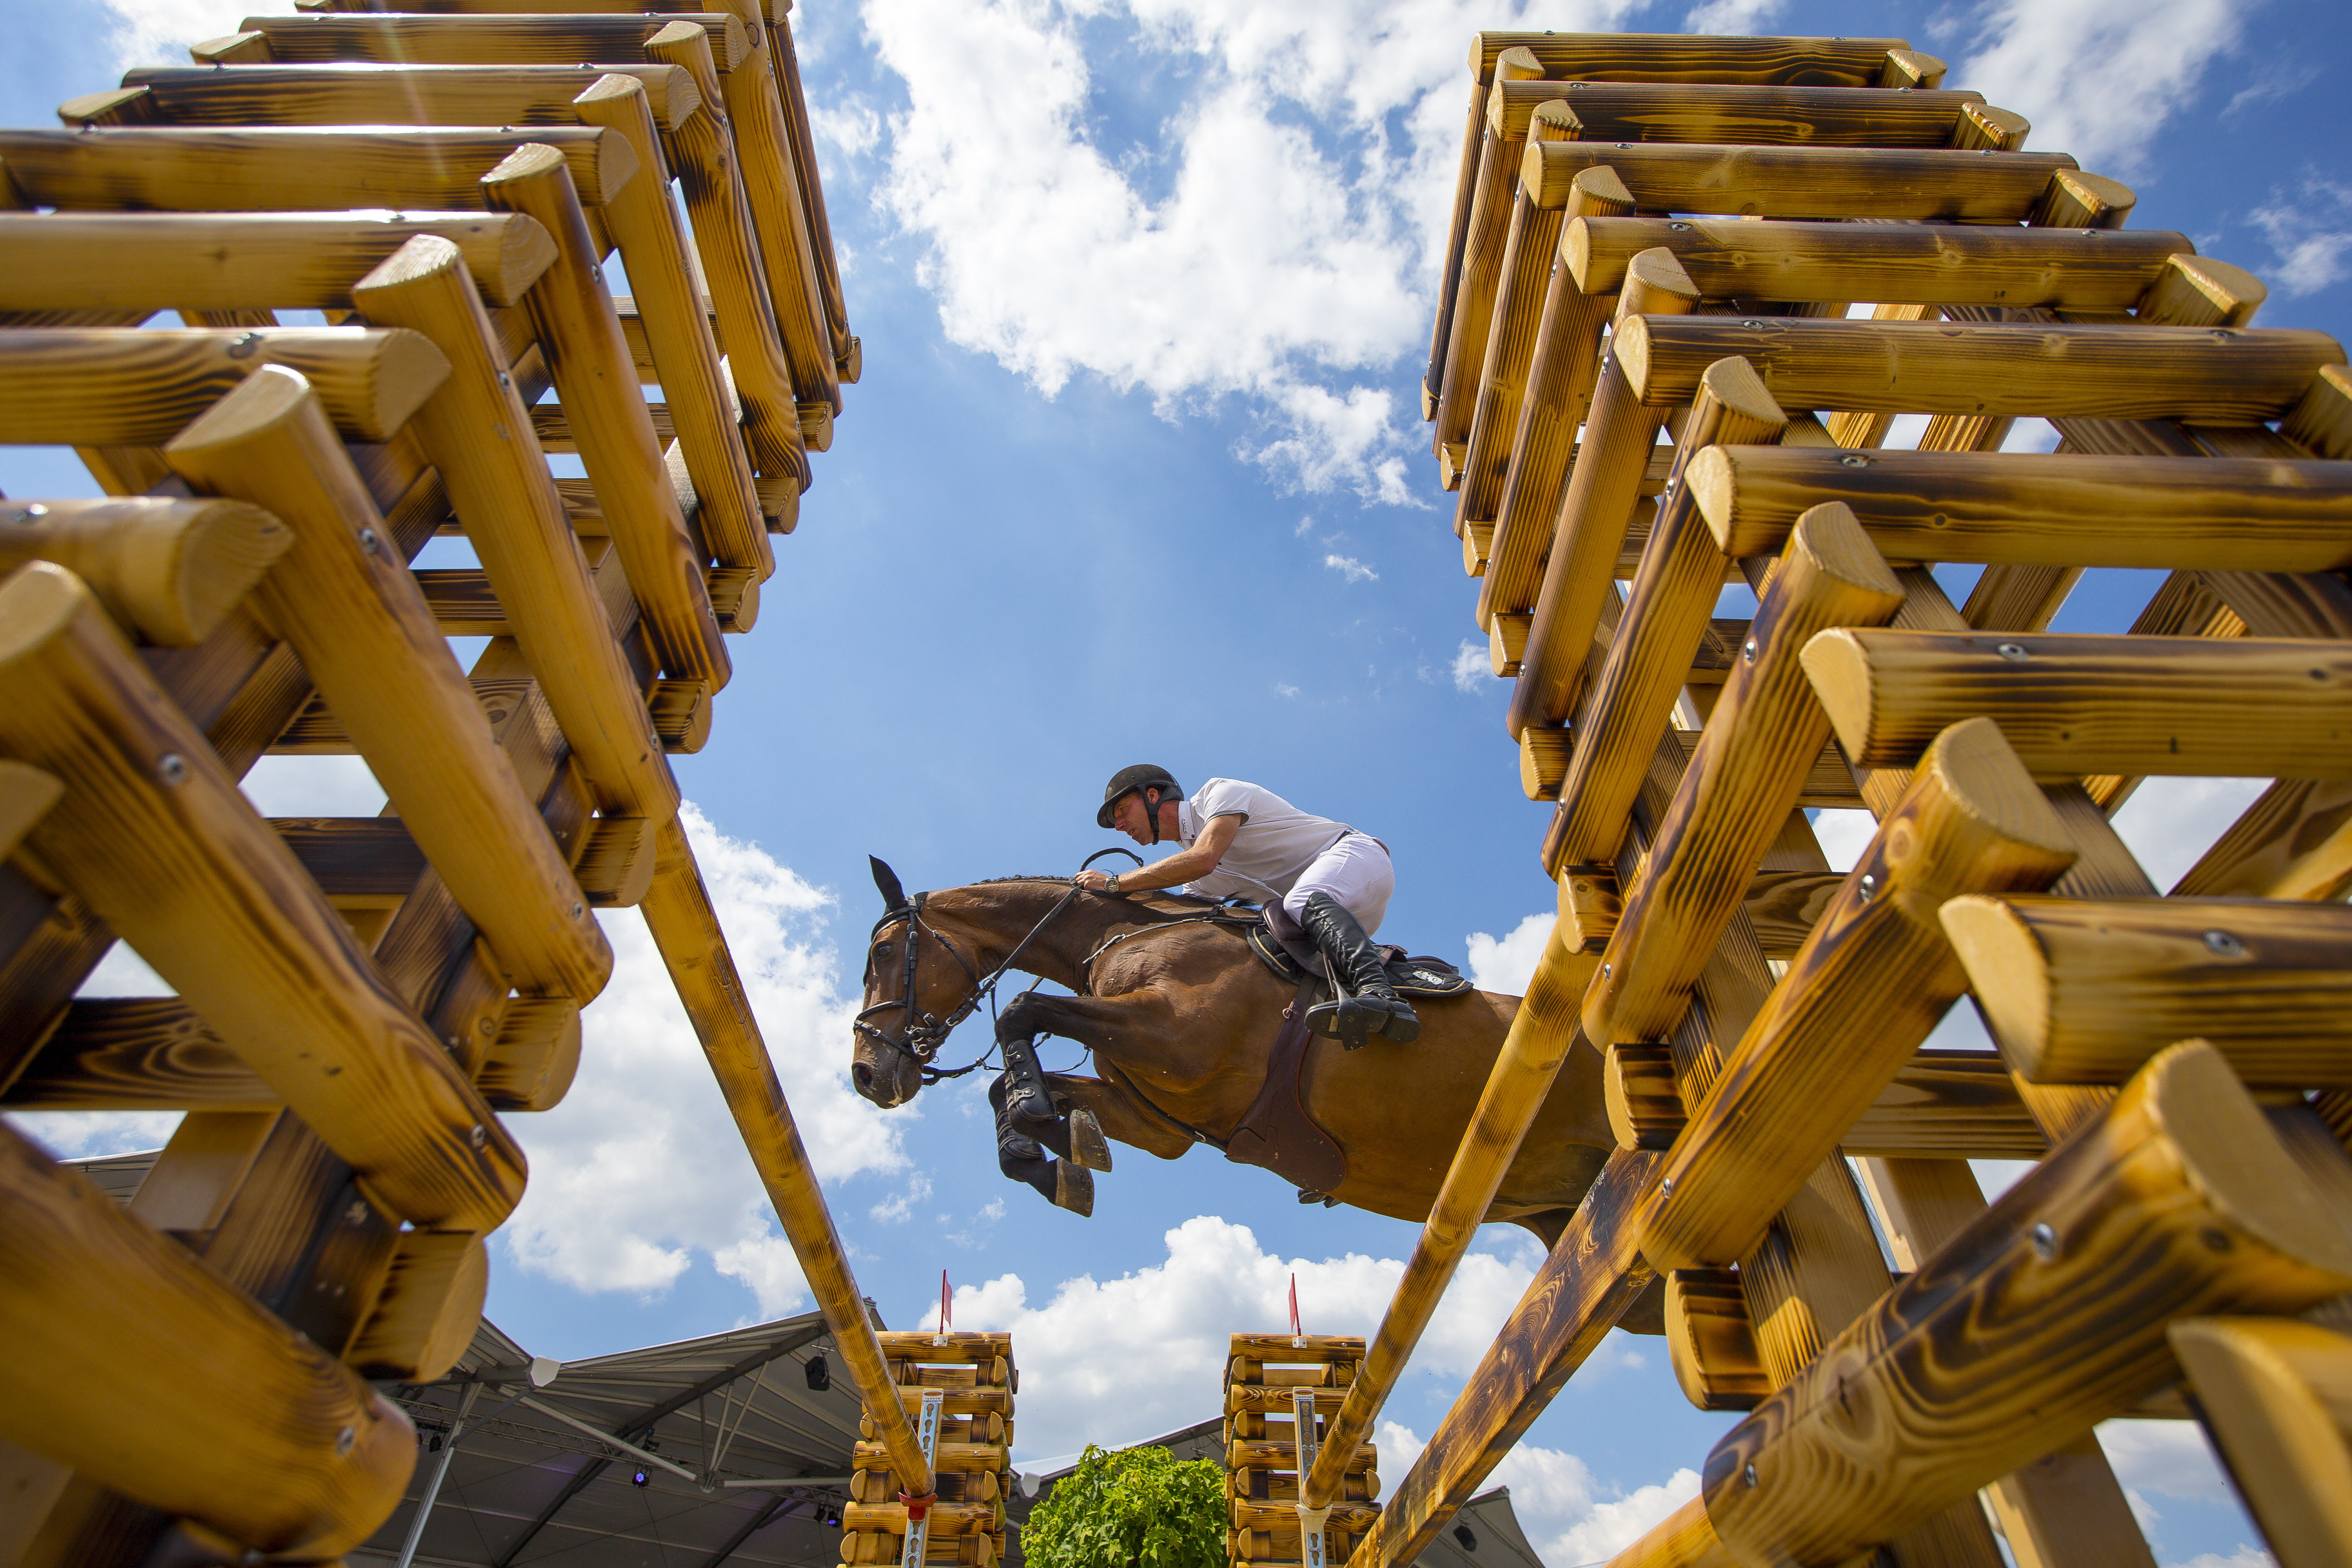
[0,0,926,1568]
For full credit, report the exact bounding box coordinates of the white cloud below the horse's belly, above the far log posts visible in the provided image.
[926,1215,1552,1457]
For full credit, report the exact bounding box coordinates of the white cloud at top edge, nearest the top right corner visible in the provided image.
[1950,0,2244,179]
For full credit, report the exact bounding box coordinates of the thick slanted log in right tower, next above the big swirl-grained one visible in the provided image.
[1637,720,2074,1267]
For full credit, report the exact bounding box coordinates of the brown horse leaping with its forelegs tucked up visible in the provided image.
[849,863,1616,1246]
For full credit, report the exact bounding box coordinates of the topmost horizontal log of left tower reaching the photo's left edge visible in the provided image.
[0,125,637,211]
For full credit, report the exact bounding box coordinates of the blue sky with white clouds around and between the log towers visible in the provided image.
[0,0,2352,1568]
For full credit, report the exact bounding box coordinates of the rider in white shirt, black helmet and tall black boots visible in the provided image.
[988,762,1421,1201]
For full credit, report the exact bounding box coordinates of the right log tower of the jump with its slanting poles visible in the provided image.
[1291,33,2352,1568]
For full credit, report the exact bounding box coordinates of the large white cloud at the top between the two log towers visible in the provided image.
[866,0,1637,505]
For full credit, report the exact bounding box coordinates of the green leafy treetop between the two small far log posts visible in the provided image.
[1021,1443,1225,1568]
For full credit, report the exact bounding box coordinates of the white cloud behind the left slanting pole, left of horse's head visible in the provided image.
[503,804,920,1312]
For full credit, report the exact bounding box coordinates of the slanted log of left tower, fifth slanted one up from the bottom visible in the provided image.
[482,142,734,691]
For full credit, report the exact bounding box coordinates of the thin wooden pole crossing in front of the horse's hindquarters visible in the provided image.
[1305,921,1599,1507]
